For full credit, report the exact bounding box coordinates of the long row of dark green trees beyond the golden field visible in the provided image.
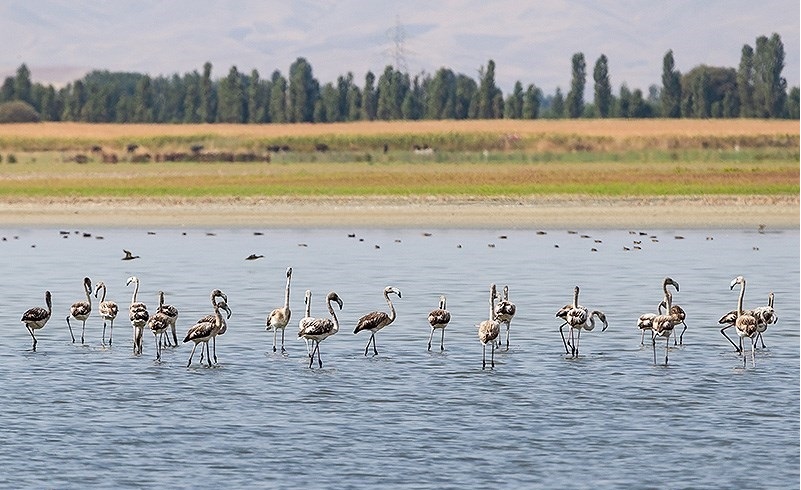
[0,34,799,123]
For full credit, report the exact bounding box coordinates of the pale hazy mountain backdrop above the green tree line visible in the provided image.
[0,0,801,95]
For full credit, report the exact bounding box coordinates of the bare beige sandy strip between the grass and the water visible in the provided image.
[0,196,799,229]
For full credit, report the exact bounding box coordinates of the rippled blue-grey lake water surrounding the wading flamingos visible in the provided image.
[0,229,799,488]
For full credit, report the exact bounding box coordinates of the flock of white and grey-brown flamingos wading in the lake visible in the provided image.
[21,267,778,369]
